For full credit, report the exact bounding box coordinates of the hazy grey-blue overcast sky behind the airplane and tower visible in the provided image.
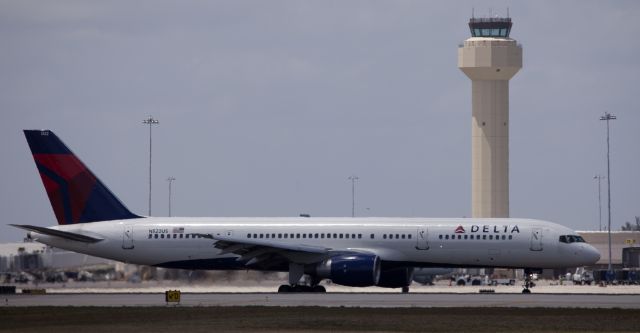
[0,0,640,241]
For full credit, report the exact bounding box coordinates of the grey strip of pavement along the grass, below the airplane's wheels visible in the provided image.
[5,293,640,309]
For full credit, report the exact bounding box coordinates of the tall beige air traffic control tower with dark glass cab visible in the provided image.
[458,17,522,217]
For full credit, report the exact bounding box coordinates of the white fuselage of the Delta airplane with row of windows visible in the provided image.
[30,217,600,269]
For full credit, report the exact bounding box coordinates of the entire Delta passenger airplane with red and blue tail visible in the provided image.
[12,130,600,293]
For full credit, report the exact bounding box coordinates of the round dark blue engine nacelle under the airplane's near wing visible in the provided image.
[314,254,380,287]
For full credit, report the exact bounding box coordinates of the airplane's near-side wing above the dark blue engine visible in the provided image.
[199,234,344,268]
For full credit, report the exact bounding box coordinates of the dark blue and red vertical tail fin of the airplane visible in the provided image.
[24,130,140,224]
